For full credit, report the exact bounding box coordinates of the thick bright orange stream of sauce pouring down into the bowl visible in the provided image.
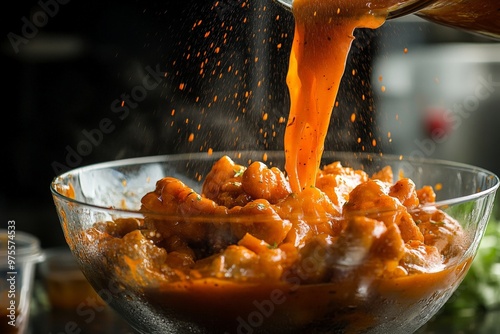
[285,0,386,193]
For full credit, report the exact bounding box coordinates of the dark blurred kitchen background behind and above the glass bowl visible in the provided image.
[0,0,500,247]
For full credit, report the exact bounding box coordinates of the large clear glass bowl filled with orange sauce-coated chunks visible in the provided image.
[51,151,499,334]
